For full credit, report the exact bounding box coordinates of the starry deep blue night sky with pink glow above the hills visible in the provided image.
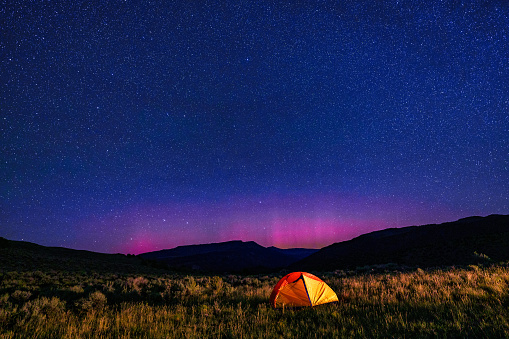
[0,0,509,253]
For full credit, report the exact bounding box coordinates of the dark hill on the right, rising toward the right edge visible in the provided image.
[290,215,509,271]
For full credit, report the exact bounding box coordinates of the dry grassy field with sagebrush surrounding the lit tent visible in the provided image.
[0,265,509,338]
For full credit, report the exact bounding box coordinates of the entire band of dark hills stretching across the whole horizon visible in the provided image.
[0,215,509,274]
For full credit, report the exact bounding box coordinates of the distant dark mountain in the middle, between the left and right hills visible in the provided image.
[139,241,318,273]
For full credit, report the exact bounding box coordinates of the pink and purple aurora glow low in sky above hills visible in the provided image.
[76,196,460,254]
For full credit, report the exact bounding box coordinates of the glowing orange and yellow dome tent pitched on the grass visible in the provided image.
[270,272,338,308]
